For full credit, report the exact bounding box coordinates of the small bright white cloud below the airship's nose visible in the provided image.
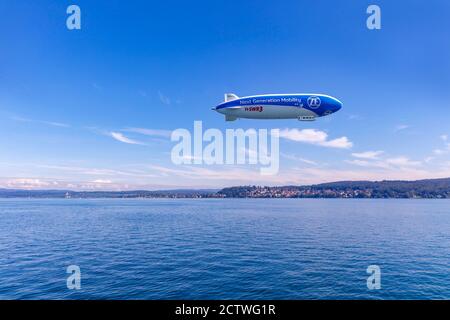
[280,129,353,149]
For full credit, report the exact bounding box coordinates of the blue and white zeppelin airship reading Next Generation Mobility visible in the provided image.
[212,93,342,121]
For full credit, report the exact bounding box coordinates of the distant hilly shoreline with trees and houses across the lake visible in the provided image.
[0,178,450,199]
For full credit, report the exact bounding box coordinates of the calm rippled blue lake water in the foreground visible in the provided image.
[0,199,450,299]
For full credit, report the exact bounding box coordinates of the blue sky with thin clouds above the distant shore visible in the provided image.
[0,0,450,190]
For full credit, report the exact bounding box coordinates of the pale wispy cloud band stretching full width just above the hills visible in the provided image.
[0,157,450,190]
